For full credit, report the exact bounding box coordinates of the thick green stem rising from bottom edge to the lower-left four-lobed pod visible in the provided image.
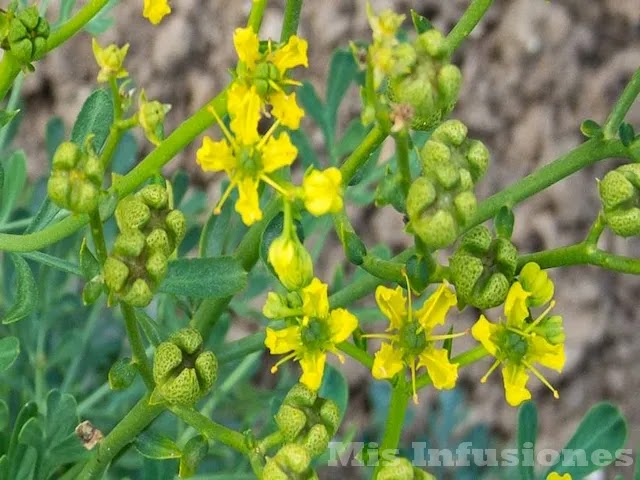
[77,395,164,480]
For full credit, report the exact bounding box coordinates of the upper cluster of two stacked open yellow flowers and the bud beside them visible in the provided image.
[196,27,342,225]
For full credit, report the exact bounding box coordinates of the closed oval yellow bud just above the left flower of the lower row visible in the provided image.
[268,233,313,291]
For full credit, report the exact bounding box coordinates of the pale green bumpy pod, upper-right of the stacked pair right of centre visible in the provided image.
[420,120,489,186]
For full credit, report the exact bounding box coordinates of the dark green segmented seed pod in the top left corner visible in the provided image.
[6,5,50,65]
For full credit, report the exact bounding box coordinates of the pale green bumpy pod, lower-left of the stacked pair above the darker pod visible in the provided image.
[407,176,477,250]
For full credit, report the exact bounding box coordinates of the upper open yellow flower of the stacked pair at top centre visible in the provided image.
[230,27,309,130]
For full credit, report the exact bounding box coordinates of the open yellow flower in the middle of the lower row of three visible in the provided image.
[365,283,460,402]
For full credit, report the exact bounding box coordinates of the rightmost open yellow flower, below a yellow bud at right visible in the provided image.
[471,282,565,406]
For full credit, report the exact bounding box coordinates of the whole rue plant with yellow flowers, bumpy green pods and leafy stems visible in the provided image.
[0,0,640,480]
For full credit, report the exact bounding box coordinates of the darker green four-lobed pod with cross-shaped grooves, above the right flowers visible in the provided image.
[449,225,518,309]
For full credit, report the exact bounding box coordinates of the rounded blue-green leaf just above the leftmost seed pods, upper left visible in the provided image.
[71,90,113,152]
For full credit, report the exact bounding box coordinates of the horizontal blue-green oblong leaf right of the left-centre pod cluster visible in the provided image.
[160,257,247,298]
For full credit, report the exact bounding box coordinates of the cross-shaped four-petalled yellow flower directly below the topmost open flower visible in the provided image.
[196,87,298,225]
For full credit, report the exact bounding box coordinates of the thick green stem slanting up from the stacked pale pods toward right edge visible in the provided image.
[469,139,627,228]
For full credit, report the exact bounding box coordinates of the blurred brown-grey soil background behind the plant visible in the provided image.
[19,0,640,472]
